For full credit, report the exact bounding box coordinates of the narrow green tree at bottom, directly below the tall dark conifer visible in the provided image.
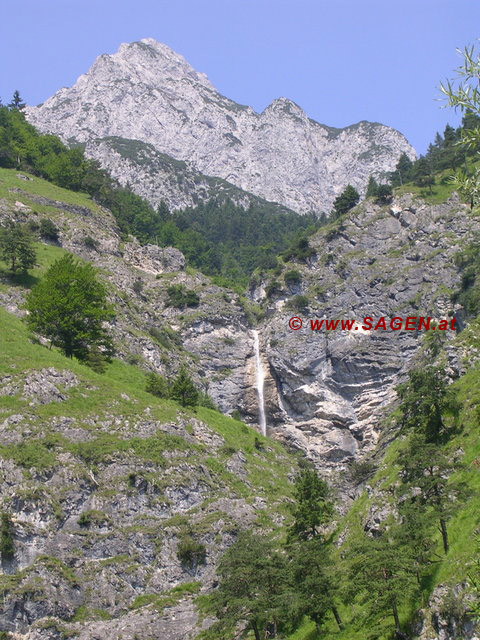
[290,536,343,635]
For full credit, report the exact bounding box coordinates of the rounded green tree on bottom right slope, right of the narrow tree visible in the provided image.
[348,527,416,640]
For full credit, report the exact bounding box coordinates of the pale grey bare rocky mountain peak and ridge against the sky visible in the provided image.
[27,38,415,213]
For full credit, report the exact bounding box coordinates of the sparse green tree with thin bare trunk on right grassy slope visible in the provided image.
[399,434,469,554]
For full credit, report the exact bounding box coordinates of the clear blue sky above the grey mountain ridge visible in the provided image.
[0,0,480,152]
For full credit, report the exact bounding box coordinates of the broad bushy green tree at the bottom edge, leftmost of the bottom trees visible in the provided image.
[212,531,302,640]
